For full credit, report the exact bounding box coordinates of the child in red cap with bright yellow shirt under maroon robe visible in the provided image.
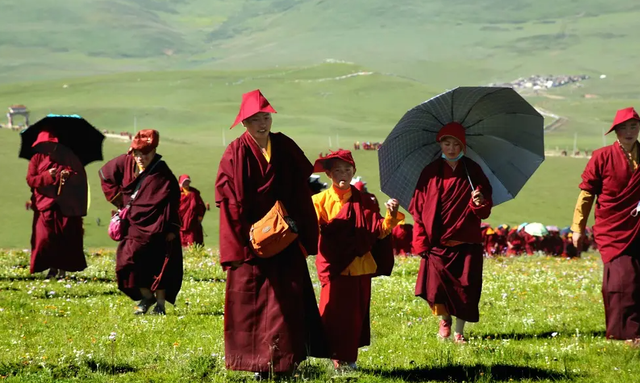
[313,149,404,369]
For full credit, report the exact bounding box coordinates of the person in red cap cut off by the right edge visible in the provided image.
[571,108,640,343]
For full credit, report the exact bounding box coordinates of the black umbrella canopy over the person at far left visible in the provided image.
[19,114,104,166]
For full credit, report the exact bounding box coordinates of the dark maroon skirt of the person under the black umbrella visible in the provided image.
[30,205,87,274]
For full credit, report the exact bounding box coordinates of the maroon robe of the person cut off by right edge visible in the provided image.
[580,142,640,339]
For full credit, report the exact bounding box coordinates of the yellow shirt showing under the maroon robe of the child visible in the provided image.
[312,185,405,276]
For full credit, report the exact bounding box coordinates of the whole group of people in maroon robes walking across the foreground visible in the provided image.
[22,89,640,378]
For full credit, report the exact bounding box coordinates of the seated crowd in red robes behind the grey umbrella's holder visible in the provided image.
[392,223,597,258]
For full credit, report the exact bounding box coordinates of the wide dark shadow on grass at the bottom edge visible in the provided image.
[360,364,577,382]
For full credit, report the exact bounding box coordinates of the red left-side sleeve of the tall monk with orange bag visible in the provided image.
[216,145,254,270]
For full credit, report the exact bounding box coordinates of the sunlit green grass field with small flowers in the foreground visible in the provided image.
[0,250,640,383]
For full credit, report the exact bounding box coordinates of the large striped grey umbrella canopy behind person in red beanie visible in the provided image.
[378,87,544,209]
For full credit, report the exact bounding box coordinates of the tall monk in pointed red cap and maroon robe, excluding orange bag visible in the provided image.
[216,89,328,379]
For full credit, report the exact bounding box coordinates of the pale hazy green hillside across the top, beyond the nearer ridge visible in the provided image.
[0,0,640,87]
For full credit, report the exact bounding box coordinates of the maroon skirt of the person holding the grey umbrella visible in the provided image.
[415,244,483,322]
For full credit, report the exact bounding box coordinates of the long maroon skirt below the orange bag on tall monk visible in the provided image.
[224,242,328,372]
